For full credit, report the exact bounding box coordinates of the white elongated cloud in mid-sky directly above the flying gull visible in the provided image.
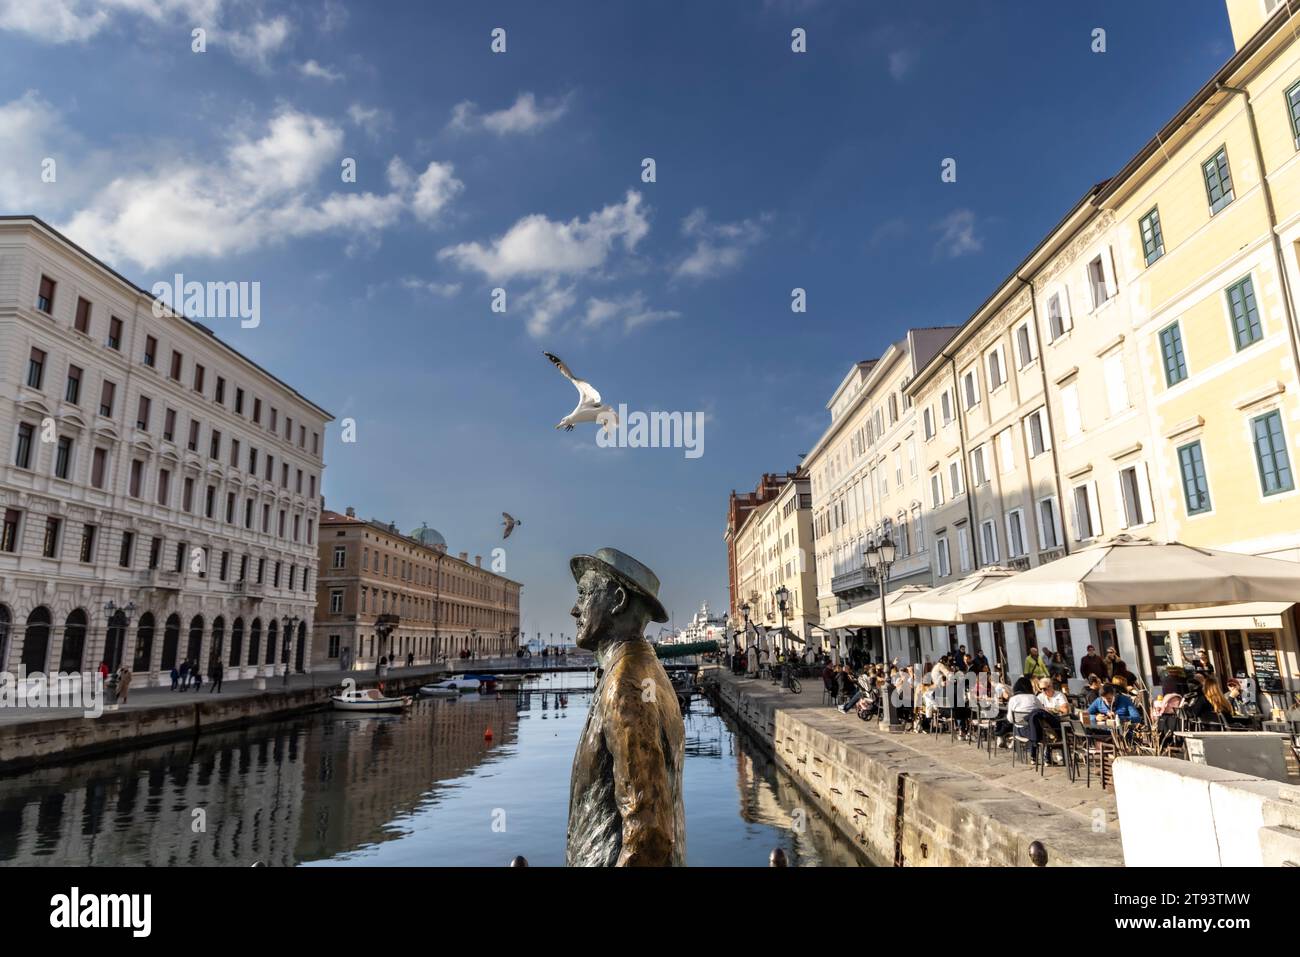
[438,190,650,280]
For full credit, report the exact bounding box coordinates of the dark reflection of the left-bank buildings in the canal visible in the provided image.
[0,697,519,866]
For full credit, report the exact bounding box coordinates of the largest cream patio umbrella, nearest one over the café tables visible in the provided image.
[957,536,1300,674]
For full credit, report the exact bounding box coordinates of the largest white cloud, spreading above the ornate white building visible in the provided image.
[11,99,460,269]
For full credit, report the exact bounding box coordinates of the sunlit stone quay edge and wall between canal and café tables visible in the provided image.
[707,668,1123,866]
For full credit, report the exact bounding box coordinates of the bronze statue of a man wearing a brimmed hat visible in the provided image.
[566,549,686,867]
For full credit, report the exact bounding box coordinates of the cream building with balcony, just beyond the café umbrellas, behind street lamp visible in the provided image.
[803,326,956,661]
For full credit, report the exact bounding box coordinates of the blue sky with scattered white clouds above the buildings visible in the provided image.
[0,0,1231,635]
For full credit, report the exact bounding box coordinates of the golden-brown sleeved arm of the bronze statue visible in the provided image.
[605,687,673,867]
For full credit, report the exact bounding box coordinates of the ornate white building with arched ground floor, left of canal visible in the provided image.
[0,216,332,683]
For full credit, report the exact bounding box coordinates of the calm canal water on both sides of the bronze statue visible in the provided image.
[0,675,867,866]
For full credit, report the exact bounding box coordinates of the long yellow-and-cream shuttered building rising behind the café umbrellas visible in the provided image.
[909,0,1300,690]
